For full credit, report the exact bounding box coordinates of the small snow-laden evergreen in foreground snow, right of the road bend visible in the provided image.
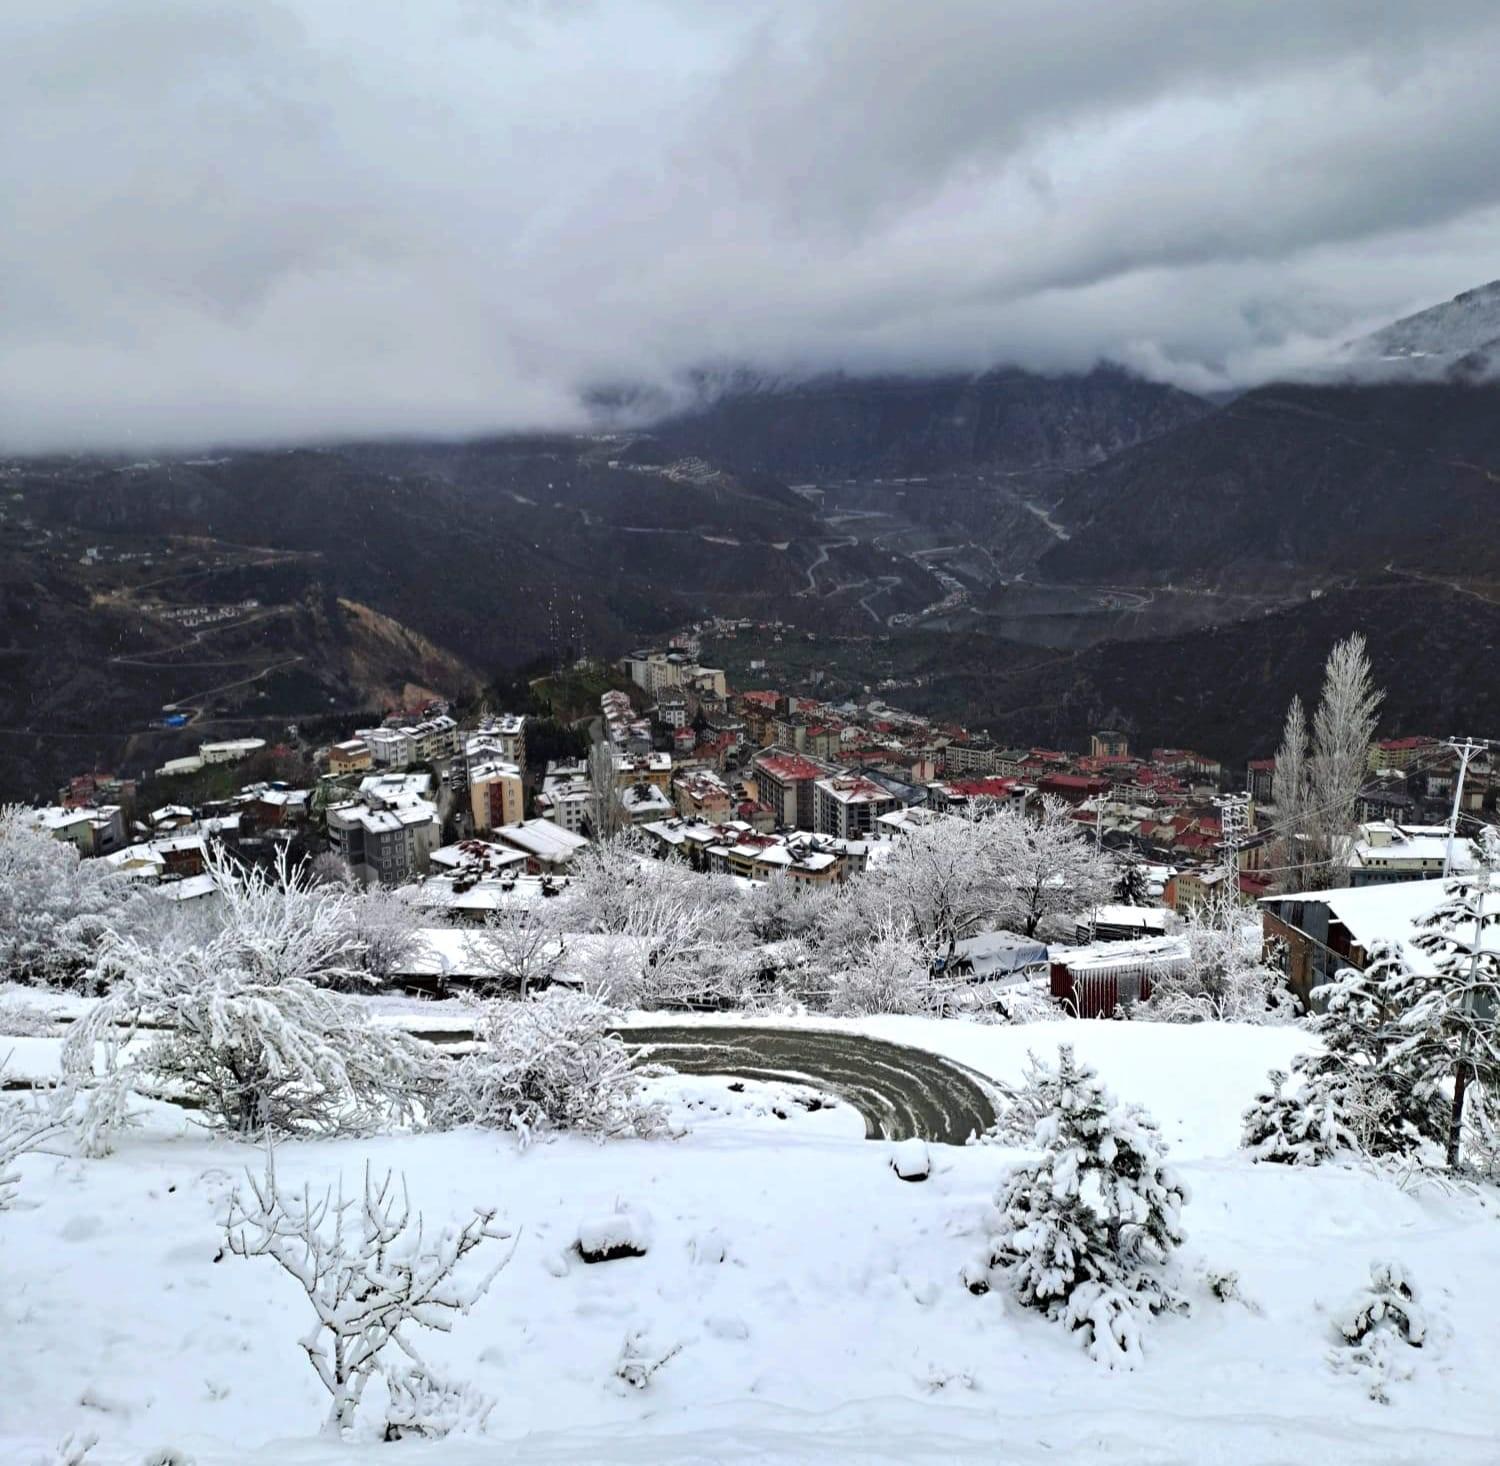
[969,1044,1188,1365]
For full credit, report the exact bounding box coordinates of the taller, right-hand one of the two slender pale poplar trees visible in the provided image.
[1307,632,1385,890]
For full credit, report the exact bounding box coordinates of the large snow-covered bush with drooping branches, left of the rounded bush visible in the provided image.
[63,855,443,1134]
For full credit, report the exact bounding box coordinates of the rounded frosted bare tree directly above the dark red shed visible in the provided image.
[986,798,1115,936]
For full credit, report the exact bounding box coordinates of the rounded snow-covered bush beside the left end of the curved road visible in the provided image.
[431,989,666,1145]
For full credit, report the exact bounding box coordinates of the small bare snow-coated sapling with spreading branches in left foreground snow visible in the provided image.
[225,1152,510,1434]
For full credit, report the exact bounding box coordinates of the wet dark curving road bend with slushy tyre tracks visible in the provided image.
[620,1023,996,1145]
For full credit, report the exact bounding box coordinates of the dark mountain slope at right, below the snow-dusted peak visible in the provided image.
[1040,383,1500,585]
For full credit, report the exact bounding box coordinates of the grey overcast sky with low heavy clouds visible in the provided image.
[0,0,1500,449]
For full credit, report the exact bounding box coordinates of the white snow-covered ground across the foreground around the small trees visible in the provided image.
[0,1004,1500,1466]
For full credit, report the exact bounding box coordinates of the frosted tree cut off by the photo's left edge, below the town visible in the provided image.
[0,804,159,983]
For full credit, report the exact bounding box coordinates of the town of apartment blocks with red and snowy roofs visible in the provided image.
[17,627,1500,1016]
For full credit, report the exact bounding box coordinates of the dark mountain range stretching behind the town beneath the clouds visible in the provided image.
[0,284,1500,798]
